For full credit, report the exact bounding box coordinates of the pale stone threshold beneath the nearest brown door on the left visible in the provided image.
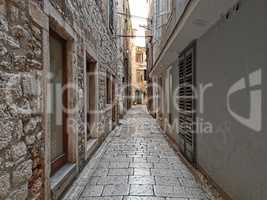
[50,163,78,199]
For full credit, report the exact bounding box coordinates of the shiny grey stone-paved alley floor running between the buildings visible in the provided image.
[65,106,215,200]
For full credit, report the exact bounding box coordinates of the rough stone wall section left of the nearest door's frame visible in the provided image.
[0,0,44,199]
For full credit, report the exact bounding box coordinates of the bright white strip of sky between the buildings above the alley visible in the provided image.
[129,0,148,47]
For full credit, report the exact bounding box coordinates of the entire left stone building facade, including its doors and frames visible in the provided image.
[0,0,131,200]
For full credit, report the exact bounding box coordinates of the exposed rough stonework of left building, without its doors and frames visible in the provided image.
[0,0,120,199]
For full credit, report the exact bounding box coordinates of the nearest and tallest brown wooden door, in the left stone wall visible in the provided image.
[49,31,68,175]
